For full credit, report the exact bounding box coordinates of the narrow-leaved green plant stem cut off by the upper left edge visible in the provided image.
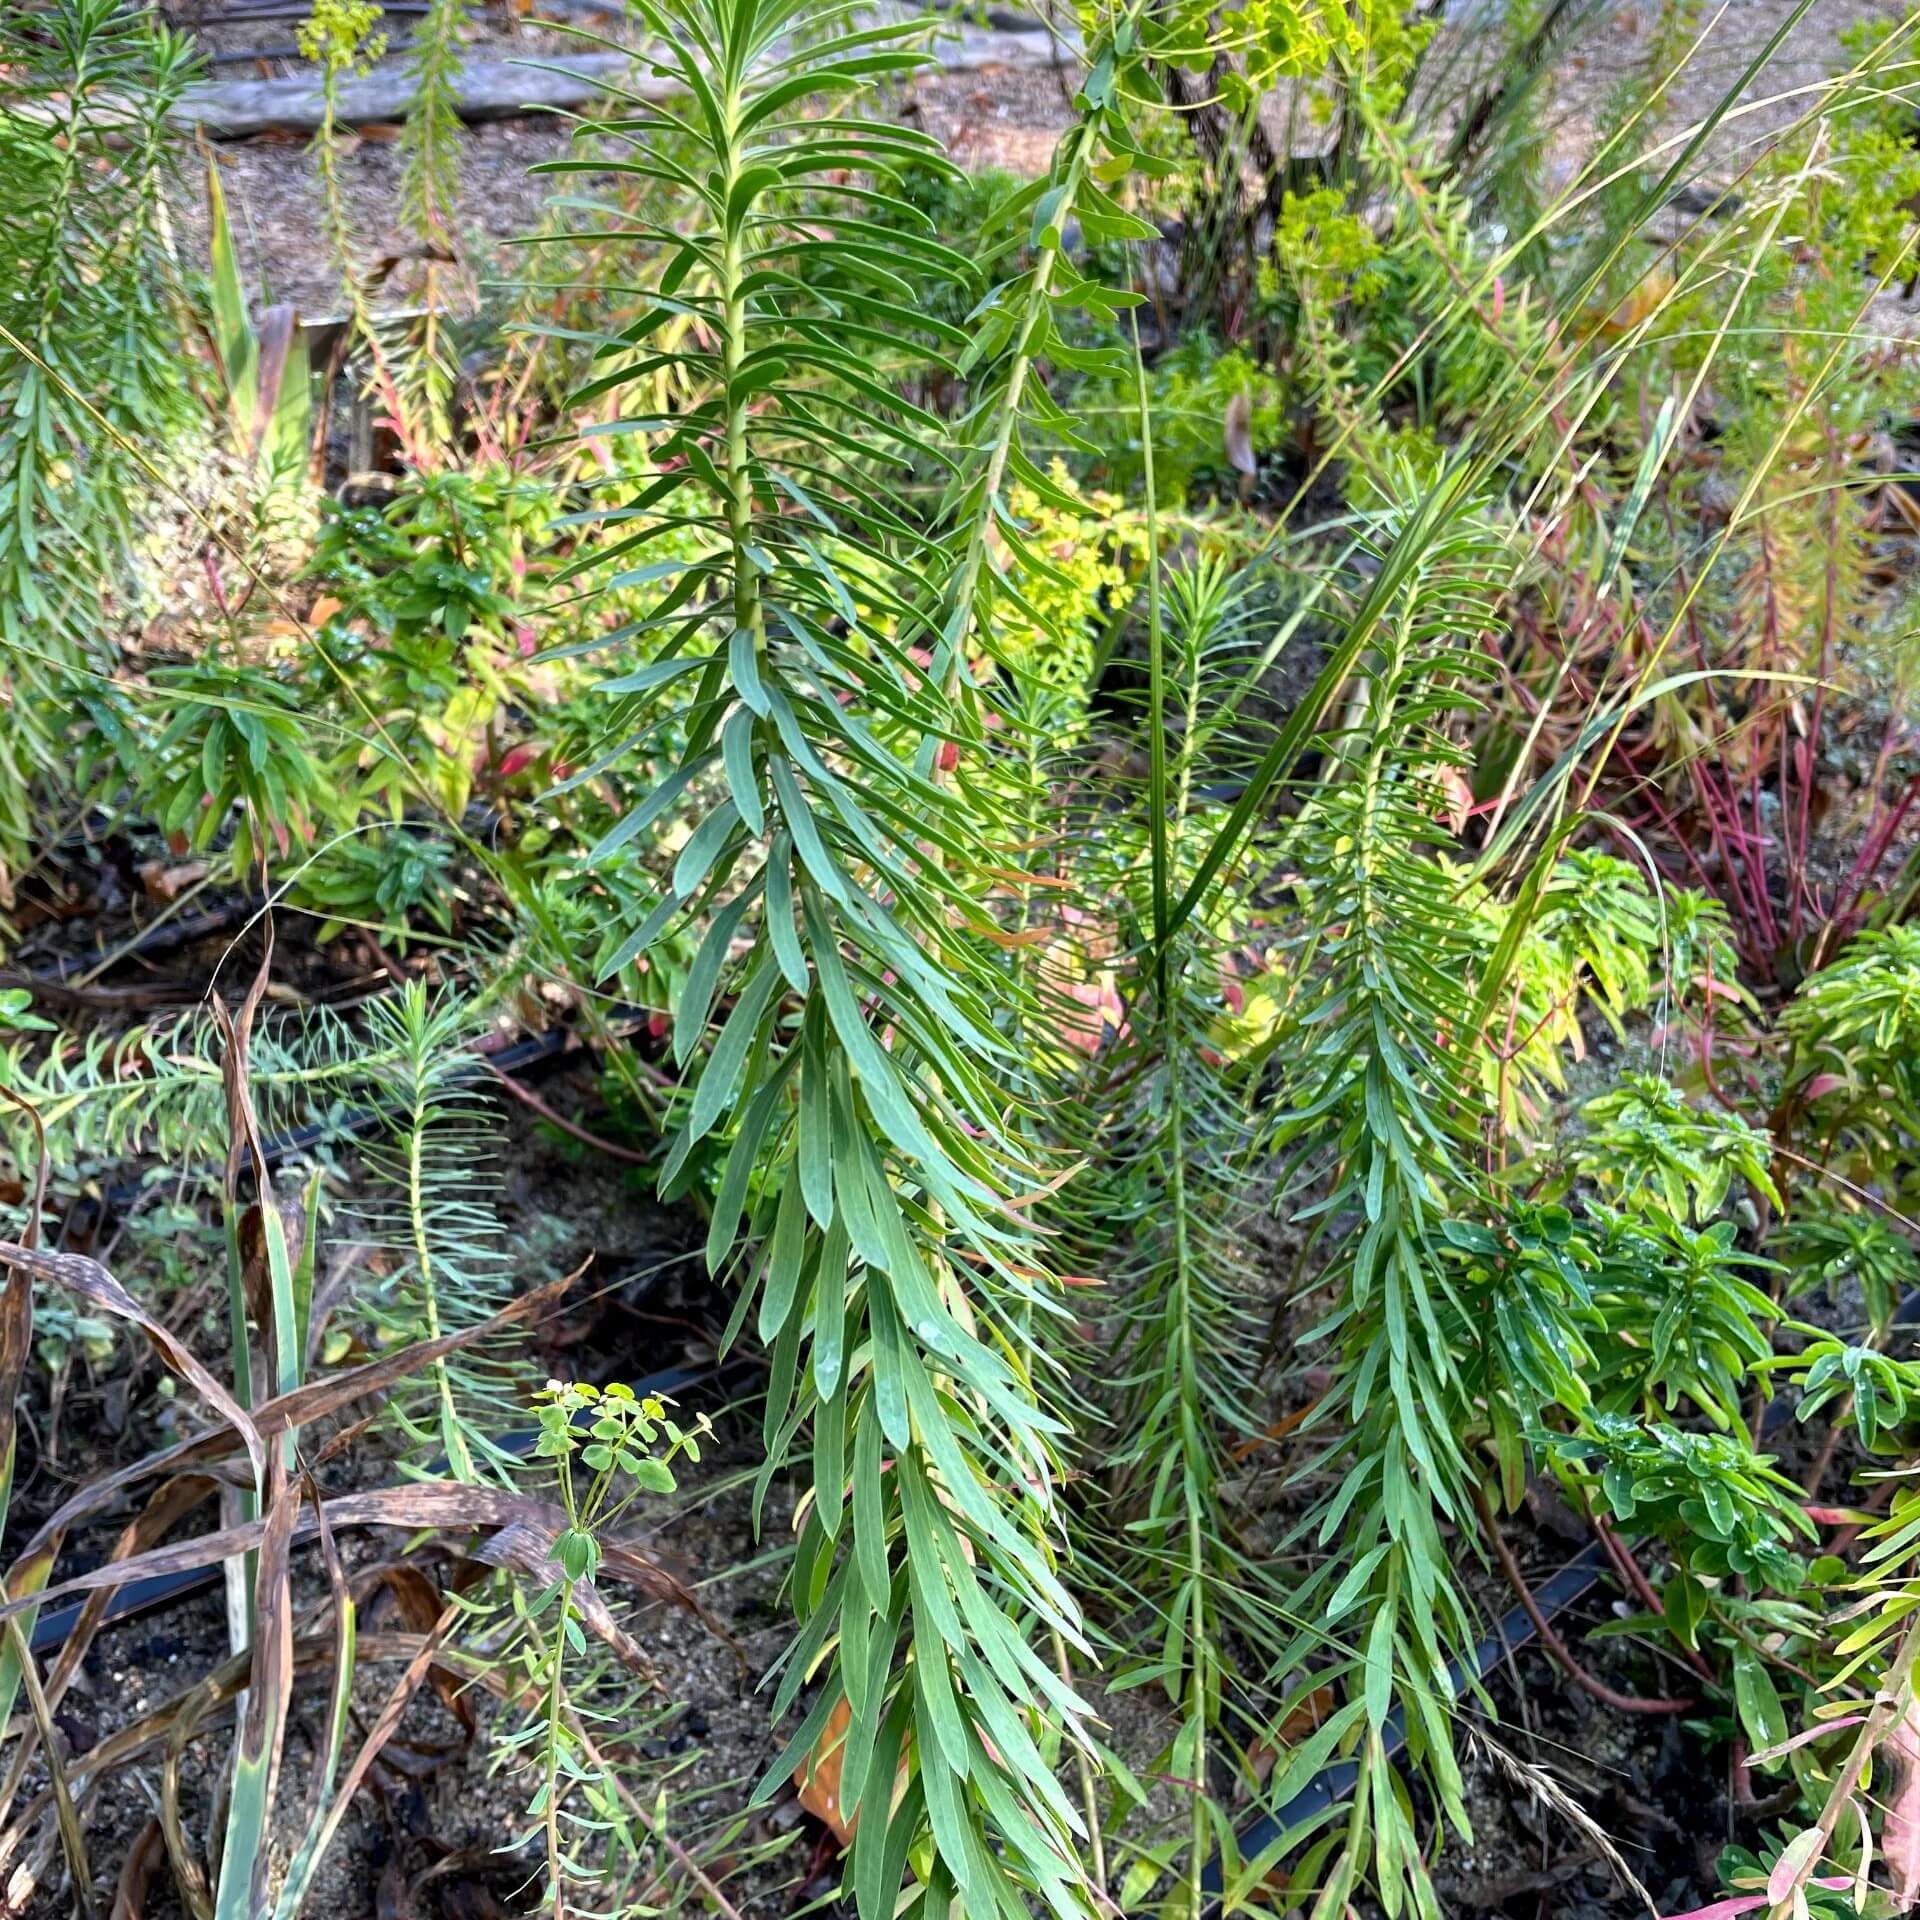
[0,0,194,904]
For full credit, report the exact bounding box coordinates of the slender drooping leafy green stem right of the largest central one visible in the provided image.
[1244,468,1501,1912]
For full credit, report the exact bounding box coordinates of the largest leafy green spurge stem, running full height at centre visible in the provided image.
[545,0,1136,1916]
